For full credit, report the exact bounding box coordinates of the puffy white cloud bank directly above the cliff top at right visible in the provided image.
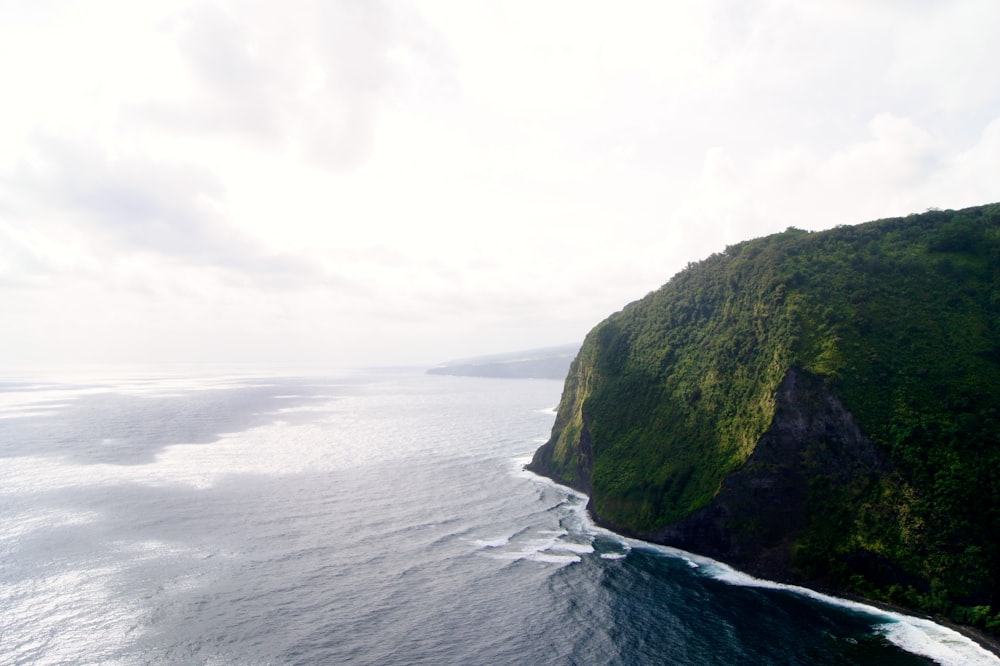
[673,113,1000,248]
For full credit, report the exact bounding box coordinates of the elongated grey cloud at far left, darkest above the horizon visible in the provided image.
[7,136,319,284]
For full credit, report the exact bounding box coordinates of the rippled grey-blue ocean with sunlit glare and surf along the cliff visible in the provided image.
[0,369,1000,666]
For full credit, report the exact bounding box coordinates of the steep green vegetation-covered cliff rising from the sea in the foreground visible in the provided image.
[529,204,1000,632]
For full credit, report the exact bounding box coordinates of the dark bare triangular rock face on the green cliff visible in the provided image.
[643,370,891,580]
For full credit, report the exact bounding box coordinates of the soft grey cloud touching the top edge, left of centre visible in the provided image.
[126,0,454,171]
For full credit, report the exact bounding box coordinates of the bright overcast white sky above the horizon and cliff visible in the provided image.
[0,0,1000,368]
